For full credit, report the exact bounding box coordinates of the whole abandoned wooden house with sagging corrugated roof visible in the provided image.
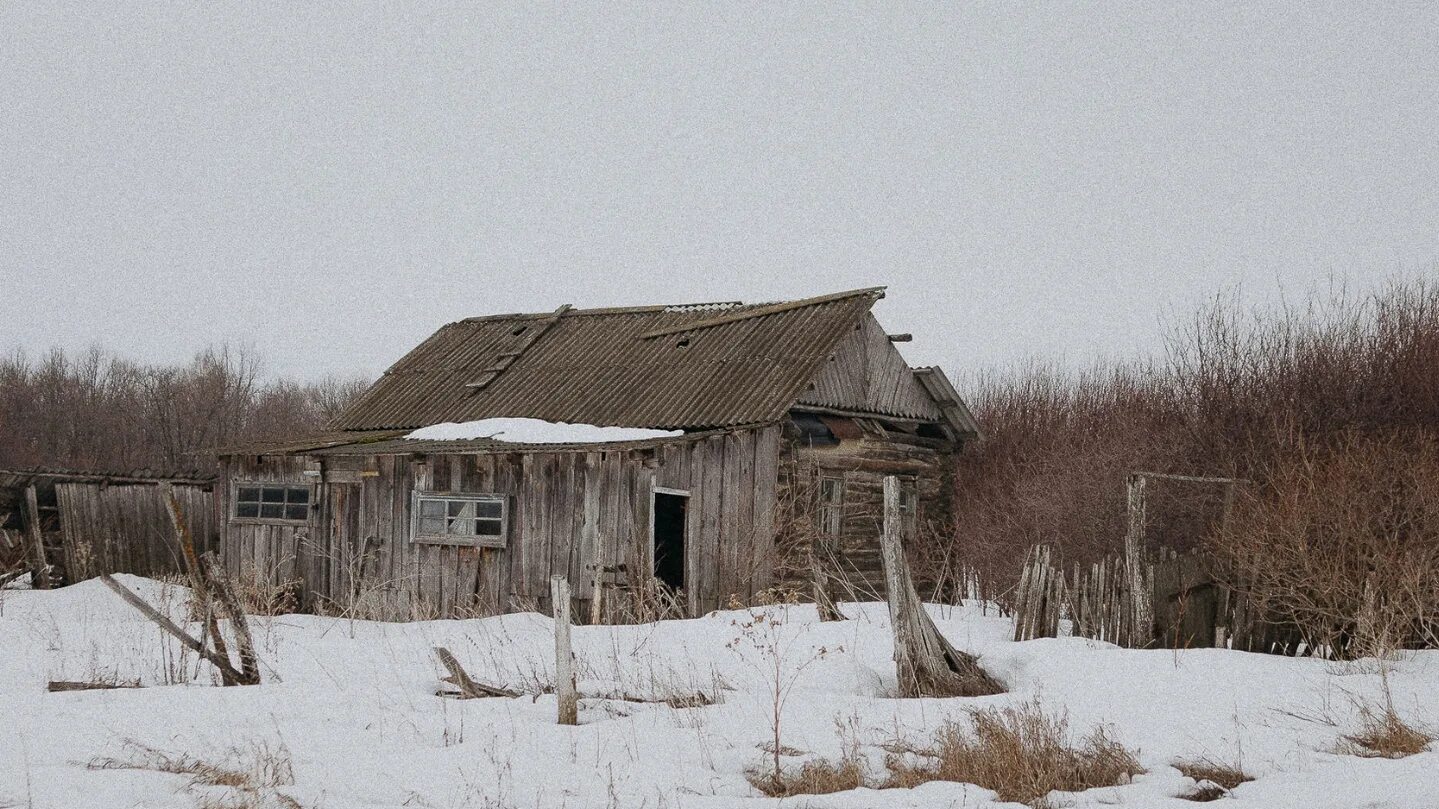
[217,288,977,620]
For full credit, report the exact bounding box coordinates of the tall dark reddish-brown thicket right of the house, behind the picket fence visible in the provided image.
[943,276,1439,624]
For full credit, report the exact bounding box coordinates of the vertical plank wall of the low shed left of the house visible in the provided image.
[55,482,217,582]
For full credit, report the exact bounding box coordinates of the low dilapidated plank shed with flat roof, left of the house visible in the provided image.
[0,469,217,587]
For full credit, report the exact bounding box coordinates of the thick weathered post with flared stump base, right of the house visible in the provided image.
[879,475,1004,697]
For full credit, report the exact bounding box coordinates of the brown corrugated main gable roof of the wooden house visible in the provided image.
[332,288,884,430]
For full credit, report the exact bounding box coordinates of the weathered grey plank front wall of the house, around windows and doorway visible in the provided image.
[220,426,780,619]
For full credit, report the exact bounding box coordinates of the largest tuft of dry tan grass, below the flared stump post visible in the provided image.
[885,702,1144,806]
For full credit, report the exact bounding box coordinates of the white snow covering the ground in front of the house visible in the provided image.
[0,576,1439,809]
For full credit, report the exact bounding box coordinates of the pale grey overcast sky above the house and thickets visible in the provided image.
[0,1,1439,377]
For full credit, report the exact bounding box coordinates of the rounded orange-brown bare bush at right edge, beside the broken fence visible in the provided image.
[1210,430,1439,659]
